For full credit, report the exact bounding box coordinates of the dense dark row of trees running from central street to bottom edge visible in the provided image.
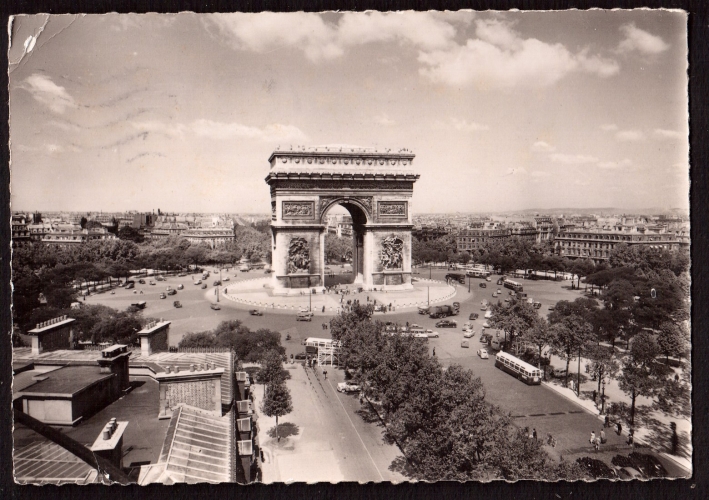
[330,305,585,480]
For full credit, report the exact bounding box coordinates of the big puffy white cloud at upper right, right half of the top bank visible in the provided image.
[418,20,620,88]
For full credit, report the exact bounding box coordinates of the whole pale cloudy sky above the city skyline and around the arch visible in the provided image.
[9,11,689,213]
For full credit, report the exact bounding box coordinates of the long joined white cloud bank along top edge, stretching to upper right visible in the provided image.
[204,12,620,87]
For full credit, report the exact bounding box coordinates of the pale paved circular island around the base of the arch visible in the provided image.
[219,277,456,315]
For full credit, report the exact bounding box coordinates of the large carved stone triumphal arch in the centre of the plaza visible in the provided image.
[266,146,419,295]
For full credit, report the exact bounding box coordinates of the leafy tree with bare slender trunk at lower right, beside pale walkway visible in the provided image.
[618,332,669,427]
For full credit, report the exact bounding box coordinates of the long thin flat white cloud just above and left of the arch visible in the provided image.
[133,119,308,142]
